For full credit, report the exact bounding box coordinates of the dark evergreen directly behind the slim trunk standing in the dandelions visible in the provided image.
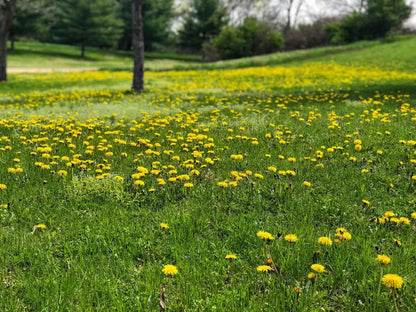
[118,0,174,51]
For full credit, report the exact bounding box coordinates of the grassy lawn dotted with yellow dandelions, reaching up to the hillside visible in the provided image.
[0,37,416,312]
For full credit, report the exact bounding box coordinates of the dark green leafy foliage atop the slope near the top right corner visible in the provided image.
[327,0,411,44]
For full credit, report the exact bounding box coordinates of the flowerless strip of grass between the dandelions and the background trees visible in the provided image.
[9,36,416,71]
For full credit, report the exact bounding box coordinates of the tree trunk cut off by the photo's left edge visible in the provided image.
[0,0,16,82]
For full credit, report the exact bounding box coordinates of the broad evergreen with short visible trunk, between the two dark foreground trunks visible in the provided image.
[56,0,123,57]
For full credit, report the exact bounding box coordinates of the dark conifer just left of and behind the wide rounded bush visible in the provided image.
[179,0,227,52]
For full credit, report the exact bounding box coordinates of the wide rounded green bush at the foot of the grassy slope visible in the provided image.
[204,18,284,61]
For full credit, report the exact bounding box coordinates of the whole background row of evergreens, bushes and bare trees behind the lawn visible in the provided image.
[4,0,411,60]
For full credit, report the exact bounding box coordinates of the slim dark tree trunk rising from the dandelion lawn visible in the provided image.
[131,0,144,92]
